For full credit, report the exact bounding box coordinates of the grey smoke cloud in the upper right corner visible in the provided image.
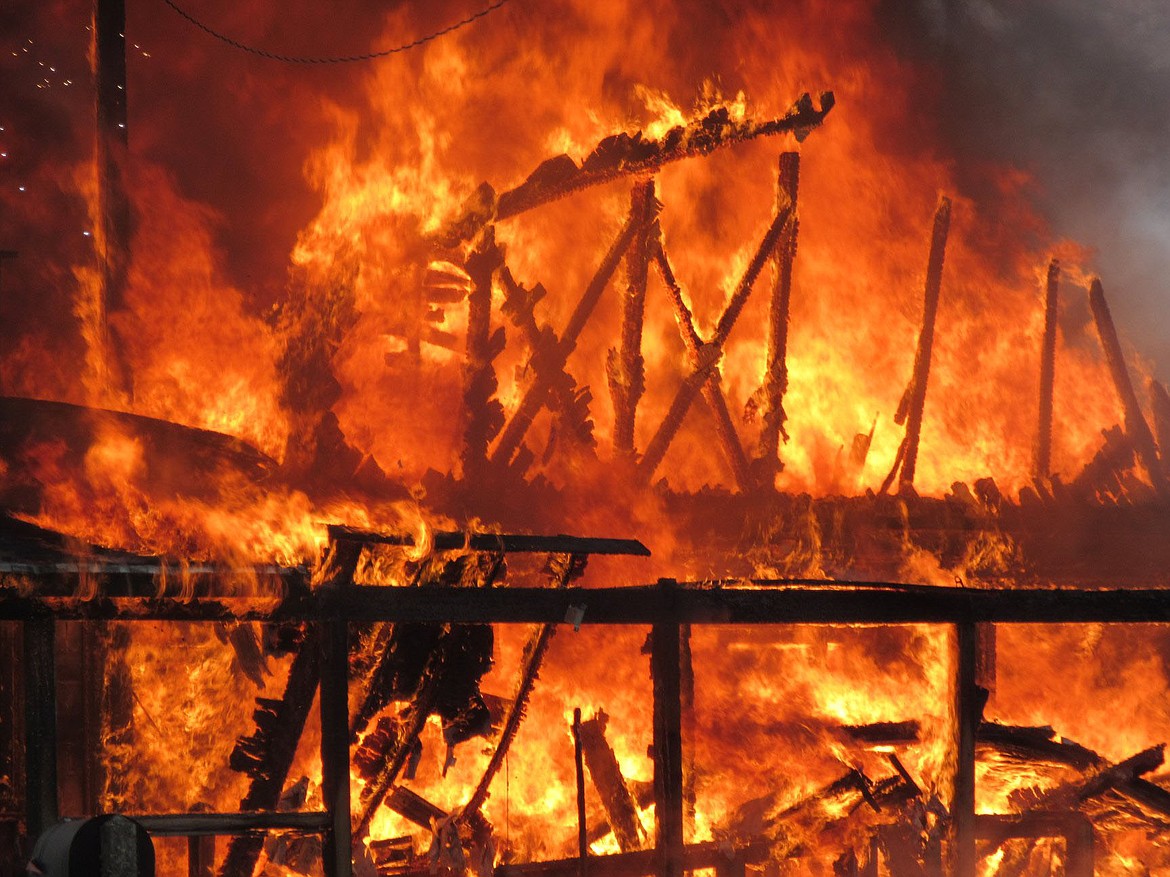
[883,0,1170,379]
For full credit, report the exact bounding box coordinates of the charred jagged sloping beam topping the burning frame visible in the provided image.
[482,91,834,230]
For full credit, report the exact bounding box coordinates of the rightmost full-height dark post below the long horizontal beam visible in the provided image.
[951,621,980,877]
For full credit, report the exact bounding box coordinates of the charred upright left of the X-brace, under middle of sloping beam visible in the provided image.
[606,179,661,458]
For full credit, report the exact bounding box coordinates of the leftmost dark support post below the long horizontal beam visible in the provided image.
[23,616,61,841]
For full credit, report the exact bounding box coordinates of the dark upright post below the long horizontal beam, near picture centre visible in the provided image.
[651,579,686,877]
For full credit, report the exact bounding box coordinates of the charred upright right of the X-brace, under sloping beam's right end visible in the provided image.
[756,152,800,486]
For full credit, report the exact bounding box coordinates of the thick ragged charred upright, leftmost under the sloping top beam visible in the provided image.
[462,227,504,478]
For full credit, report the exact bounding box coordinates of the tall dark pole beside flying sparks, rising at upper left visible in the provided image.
[94,0,130,393]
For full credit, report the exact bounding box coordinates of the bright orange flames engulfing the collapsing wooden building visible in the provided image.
[0,2,1170,875]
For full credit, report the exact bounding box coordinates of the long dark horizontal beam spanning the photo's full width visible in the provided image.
[0,580,1170,624]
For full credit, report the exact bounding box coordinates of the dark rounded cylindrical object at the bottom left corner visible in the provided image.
[32,815,154,877]
